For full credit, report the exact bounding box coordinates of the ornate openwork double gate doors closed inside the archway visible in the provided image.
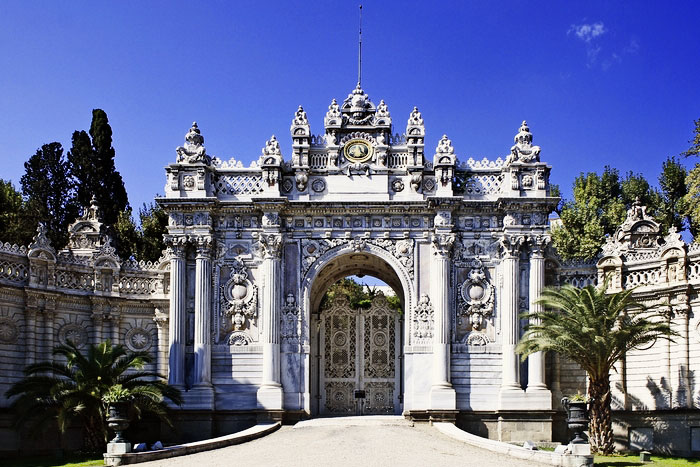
[320,295,401,415]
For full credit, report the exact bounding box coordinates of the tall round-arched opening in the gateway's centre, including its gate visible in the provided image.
[309,252,406,416]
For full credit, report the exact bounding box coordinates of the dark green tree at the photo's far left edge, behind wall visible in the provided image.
[0,179,36,246]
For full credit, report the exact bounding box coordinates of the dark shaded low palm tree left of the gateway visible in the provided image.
[5,340,182,452]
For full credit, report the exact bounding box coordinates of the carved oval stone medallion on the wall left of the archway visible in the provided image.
[221,259,258,331]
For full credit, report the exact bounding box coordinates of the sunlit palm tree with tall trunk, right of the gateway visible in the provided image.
[516,281,677,454]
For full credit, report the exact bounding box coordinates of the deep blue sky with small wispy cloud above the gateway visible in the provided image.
[0,0,700,214]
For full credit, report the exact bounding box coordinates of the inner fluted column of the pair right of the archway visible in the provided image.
[500,236,523,392]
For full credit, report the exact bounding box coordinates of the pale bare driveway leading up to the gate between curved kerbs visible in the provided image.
[140,424,542,467]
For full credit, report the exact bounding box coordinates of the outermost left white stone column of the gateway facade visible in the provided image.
[168,244,185,387]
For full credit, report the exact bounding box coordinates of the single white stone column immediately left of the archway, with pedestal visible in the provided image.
[258,233,284,410]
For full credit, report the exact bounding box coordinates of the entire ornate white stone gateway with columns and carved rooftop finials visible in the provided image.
[158,85,558,439]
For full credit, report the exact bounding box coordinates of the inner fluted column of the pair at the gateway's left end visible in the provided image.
[194,237,211,386]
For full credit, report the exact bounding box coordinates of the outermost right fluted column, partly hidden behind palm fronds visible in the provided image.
[527,236,549,392]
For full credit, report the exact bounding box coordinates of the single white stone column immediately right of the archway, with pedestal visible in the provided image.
[430,232,457,410]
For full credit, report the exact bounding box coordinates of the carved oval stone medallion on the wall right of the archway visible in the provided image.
[458,259,495,331]
